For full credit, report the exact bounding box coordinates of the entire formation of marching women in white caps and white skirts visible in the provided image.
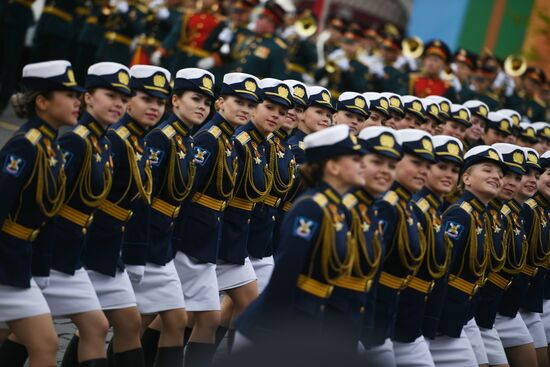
[0,60,550,367]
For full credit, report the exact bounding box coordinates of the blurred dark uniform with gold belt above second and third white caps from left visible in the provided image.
[95,3,149,65]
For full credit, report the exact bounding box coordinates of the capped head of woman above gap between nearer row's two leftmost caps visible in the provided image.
[332,92,369,135]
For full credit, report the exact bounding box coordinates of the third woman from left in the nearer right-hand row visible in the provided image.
[388,129,444,366]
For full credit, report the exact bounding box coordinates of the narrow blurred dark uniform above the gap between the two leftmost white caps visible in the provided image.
[73,0,105,83]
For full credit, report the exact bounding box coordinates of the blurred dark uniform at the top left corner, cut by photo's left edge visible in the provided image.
[0,0,34,112]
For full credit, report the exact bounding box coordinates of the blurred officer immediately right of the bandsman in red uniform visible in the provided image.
[445,48,477,103]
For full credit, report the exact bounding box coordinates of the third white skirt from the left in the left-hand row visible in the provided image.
[88,270,136,310]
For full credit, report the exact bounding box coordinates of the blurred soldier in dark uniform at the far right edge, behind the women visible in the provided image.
[506,67,546,121]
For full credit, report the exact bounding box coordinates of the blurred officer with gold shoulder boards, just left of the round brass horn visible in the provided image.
[230,0,287,79]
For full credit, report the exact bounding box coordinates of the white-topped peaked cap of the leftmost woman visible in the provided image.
[21,60,84,93]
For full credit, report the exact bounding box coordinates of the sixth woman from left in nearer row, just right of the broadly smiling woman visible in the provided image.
[475,143,526,366]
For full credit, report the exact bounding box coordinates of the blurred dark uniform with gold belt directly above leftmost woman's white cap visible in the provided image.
[31,0,77,62]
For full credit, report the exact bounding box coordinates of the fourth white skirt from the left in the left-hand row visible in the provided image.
[132,261,185,314]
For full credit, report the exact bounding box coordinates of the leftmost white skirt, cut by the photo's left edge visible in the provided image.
[0,278,50,329]
